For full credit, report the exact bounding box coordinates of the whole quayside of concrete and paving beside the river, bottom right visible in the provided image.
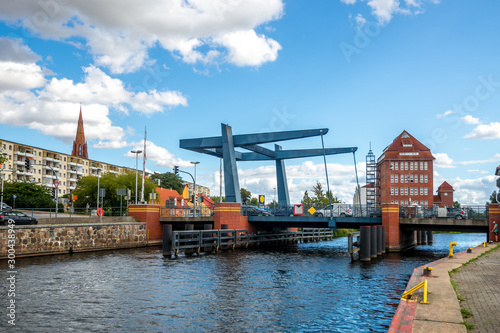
[388,244,500,333]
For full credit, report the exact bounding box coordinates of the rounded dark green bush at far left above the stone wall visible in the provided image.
[3,182,56,208]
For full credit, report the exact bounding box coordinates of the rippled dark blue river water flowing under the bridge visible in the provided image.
[0,233,486,332]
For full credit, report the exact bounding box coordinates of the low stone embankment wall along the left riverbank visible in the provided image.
[0,222,148,259]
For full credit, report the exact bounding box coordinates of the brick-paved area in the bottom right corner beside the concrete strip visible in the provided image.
[451,245,500,333]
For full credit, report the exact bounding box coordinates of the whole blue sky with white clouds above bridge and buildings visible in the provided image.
[0,0,500,204]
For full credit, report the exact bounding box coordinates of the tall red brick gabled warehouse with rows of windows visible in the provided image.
[376,131,436,206]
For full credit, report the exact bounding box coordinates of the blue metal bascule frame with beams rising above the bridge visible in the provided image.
[179,124,358,207]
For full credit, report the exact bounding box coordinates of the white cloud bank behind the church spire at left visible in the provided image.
[0,38,187,148]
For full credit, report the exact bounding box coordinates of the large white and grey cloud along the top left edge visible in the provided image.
[0,0,284,73]
